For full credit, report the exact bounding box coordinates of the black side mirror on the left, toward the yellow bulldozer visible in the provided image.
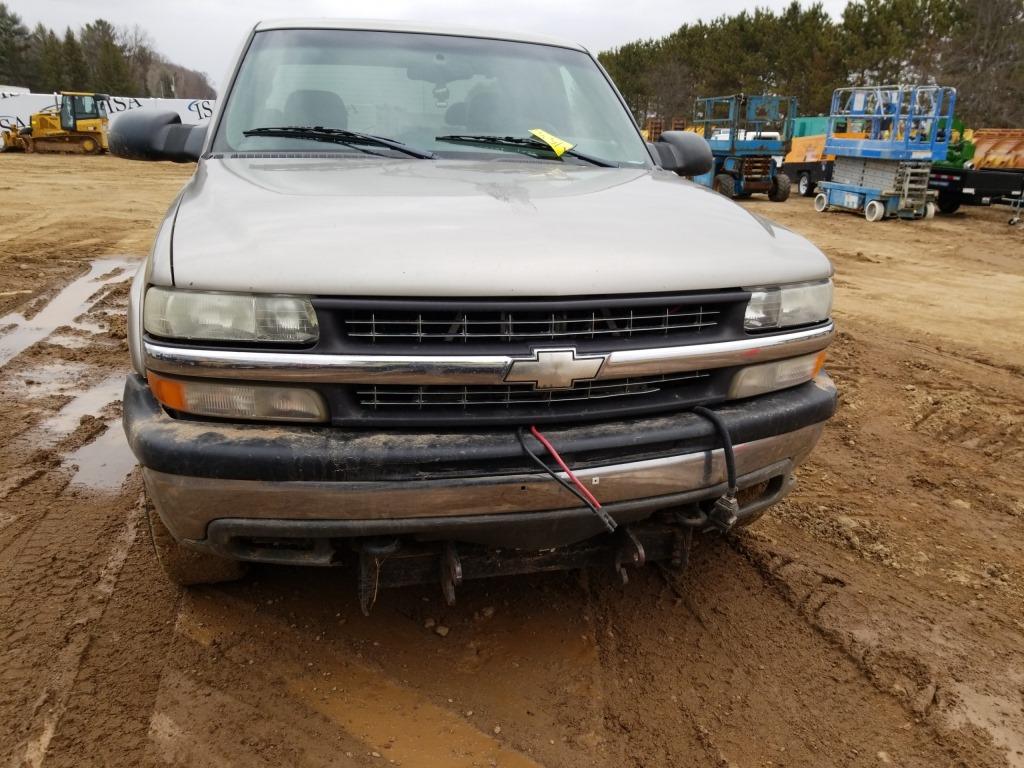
[108,112,207,163]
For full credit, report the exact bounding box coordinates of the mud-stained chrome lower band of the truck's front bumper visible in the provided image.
[142,423,824,540]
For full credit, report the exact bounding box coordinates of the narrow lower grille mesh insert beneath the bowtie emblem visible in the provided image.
[355,371,710,411]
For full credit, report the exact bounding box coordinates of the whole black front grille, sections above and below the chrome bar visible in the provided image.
[308,294,750,427]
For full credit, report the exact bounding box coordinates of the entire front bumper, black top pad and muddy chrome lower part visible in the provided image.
[124,374,836,552]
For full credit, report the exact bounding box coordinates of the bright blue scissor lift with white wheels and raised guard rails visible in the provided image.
[814,85,956,221]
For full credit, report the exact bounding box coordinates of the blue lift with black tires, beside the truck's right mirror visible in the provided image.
[693,93,797,203]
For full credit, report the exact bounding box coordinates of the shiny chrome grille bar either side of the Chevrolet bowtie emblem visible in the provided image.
[145,323,836,385]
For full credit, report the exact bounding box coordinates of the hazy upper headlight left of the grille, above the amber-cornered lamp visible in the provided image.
[143,288,319,344]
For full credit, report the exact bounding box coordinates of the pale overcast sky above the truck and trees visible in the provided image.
[4,0,847,91]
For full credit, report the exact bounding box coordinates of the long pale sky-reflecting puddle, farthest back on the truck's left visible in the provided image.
[0,258,138,366]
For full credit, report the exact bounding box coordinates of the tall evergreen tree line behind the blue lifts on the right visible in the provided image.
[599,0,1024,128]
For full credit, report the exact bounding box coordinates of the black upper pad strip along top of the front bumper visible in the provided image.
[124,375,836,482]
